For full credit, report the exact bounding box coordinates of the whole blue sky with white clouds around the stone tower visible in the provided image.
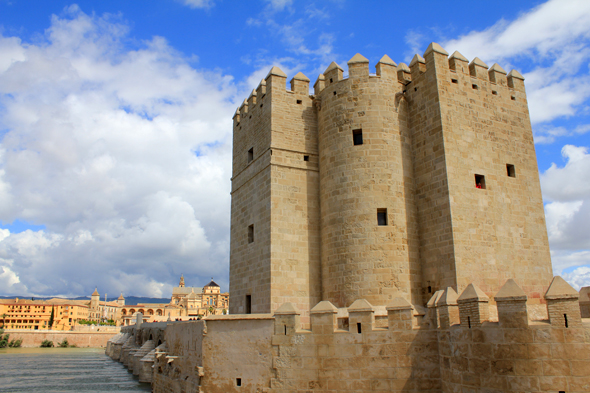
[0,0,590,297]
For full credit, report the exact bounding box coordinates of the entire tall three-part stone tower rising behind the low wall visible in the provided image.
[230,43,552,315]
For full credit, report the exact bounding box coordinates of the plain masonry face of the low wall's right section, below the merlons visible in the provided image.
[438,323,590,393]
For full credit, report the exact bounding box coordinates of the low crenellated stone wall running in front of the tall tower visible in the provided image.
[107,277,590,393]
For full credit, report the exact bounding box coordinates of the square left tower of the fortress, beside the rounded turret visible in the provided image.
[230,67,322,313]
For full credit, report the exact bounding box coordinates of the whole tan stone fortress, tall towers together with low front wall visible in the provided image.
[107,43,590,393]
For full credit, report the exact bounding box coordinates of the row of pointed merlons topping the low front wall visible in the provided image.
[274,276,582,335]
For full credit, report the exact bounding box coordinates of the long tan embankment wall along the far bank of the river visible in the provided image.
[4,329,118,348]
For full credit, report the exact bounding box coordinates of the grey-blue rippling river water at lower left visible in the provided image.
[0,348,151,393]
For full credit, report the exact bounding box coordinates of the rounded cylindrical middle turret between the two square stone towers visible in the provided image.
[316,54,422,307]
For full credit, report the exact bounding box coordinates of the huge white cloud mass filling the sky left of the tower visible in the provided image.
[0,6,238,296]
